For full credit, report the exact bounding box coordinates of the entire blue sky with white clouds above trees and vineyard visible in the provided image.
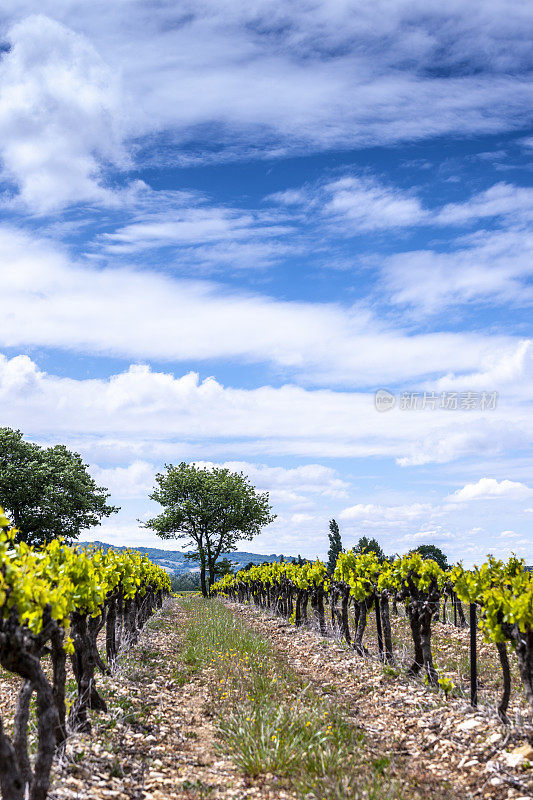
[0,0,533,565]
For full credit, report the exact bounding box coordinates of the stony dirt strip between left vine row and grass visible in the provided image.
[45,602,292,800]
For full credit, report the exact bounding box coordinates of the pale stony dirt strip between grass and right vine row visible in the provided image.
[231,605,533,800]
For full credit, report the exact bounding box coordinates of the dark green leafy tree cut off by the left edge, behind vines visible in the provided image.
[0,428,118,546]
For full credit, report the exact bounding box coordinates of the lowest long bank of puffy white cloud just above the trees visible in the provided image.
[0,356,531,466]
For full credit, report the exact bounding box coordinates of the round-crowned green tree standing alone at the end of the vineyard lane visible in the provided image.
[144,462,275,597]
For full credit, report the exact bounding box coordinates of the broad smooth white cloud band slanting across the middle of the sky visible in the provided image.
[0,223,518,386]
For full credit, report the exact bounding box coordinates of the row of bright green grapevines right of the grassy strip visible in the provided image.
[213,551,533,723]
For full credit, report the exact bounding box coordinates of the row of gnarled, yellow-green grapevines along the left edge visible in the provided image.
[0,508,170,800]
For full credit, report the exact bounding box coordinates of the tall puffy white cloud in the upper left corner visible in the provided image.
[0,15,125,212]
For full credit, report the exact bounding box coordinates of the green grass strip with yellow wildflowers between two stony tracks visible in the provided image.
[180,598,402,800]
